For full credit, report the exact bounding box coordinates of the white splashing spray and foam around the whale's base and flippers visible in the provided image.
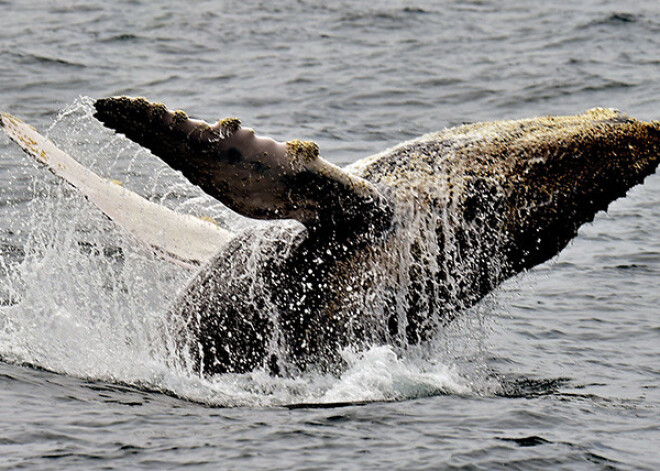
[0,98,498,406]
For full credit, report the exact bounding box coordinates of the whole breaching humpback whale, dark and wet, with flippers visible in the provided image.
[3,97,660,375]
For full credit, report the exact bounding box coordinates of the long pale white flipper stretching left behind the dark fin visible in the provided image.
[0,113,233,268]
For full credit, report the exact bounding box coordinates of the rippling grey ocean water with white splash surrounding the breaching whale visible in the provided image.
[0,0,660,470]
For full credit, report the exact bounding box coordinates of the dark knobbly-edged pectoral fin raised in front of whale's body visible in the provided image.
[94,97,391,242]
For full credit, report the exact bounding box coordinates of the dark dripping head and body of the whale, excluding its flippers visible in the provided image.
[93,99,660,375]
